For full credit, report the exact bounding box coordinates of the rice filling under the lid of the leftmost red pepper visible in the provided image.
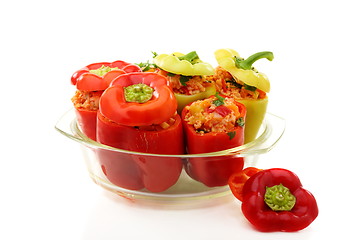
[71,90,103,111]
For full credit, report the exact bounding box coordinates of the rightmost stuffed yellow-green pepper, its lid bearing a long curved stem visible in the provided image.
[214,49,274,143]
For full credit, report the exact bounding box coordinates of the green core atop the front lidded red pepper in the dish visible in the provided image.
[124,83,154,103]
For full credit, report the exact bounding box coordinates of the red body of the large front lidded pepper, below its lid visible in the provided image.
[97,112,184,192]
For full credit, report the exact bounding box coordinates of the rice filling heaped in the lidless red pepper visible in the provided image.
[184,98,240,134]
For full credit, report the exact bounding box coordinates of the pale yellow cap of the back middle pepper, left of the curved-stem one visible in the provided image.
[154,52,214,76]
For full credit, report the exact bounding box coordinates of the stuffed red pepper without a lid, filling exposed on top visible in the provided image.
[182,95,246,187]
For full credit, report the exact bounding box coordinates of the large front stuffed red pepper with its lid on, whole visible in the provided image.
[97,72,184,192]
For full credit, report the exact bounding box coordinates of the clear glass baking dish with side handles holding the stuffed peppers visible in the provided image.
[55,109,285,203]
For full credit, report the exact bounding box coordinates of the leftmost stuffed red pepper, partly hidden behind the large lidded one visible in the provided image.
[71,60,141,140]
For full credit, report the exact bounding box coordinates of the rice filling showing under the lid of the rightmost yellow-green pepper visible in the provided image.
[207,67,266,99]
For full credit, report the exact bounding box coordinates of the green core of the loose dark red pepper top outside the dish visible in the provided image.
[264,184,296,211]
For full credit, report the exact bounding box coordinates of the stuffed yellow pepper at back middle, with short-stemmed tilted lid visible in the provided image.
[154,51,216,113]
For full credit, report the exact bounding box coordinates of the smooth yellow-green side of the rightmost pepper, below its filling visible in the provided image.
[236,97,268,143]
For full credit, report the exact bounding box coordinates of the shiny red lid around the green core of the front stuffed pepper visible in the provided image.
[99,72,177,126]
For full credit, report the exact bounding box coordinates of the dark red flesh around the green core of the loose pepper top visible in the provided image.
[241,168,319,232]
